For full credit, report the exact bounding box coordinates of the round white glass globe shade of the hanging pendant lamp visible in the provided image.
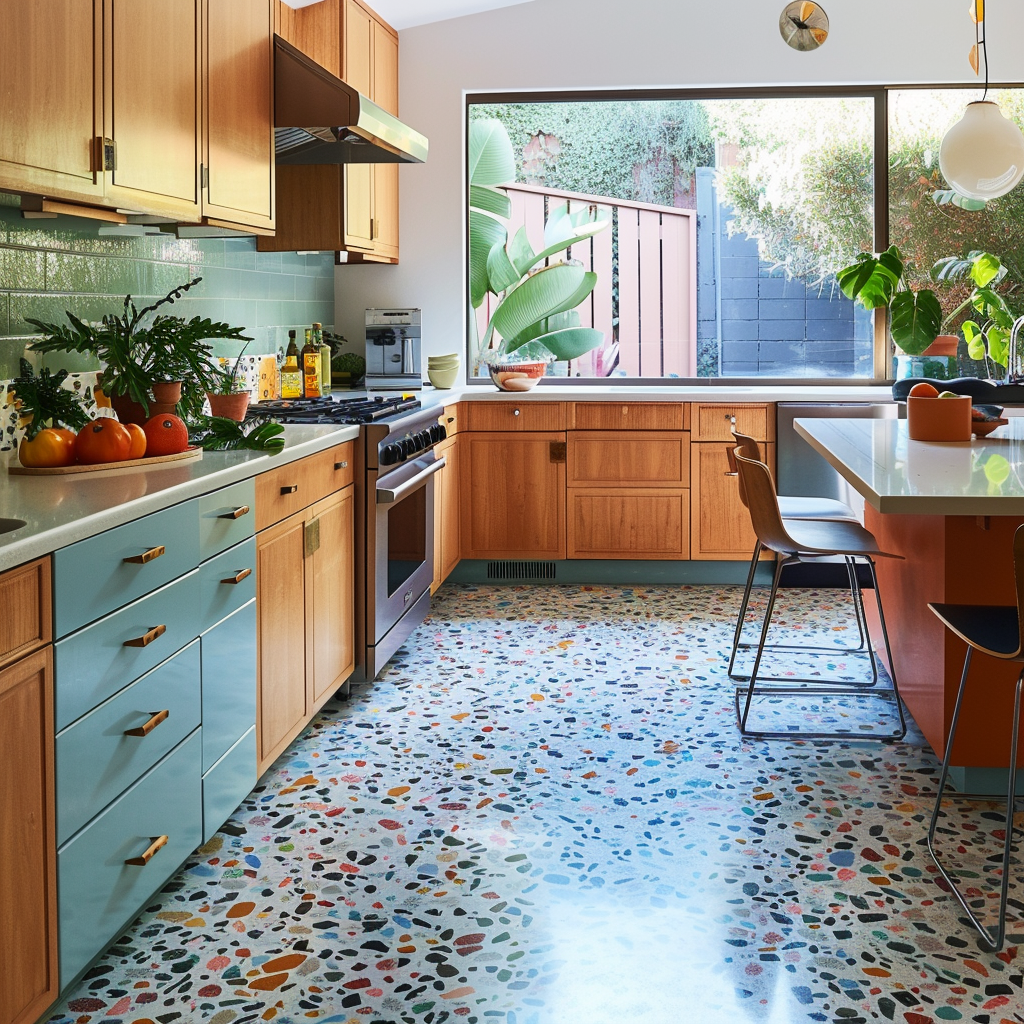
[939,100,1024,200]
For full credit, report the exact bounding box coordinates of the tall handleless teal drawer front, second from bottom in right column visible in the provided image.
[200,599,256,771]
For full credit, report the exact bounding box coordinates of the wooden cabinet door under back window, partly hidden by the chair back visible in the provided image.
[690,443,775,560]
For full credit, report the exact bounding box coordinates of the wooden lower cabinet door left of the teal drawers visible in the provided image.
[0,647,57,1024]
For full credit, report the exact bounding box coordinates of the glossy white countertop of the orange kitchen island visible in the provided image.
[794,418,1024,516]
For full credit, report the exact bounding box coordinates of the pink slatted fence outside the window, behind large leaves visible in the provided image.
[477,184,697,377]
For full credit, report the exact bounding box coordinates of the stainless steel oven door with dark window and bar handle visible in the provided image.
[367,452,444,678]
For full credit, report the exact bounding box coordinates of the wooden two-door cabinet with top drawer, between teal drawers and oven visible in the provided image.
[256,442,355,774]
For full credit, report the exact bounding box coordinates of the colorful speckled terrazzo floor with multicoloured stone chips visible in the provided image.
[52,586,1024,1024]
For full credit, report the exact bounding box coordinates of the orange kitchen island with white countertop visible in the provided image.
[796,419,1024,793]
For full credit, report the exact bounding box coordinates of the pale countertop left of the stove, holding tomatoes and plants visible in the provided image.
[0,426,359,571]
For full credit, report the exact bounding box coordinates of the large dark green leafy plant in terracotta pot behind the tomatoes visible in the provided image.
[26,278,250,423]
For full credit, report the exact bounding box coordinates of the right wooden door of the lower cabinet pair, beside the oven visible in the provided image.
[306,486,355,714]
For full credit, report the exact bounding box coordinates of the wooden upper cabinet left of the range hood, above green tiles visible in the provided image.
[0,0,273,230]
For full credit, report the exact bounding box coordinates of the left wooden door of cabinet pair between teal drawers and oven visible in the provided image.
[256,513,306,774]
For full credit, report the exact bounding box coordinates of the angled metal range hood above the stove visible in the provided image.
[273,35,427,164]
